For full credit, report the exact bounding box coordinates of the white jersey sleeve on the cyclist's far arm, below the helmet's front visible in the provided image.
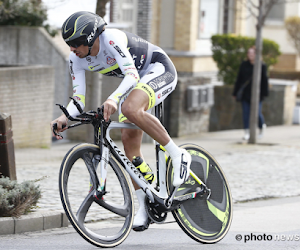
[67,53,86,117]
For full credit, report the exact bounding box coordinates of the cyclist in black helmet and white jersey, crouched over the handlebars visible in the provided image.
[50,11,191,231]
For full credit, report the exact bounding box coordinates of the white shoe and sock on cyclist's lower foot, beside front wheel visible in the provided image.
[132,189,151,232]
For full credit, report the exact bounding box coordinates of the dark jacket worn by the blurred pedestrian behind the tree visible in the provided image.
[232,60,269,102]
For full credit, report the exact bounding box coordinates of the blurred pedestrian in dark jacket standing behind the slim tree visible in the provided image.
[232,46,269,140]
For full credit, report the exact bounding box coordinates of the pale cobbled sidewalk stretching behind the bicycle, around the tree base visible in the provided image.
[0,125,300,234]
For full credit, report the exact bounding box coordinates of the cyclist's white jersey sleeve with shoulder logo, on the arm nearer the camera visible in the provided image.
[104,32,140,104]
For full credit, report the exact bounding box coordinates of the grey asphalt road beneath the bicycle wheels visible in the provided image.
[0,196,300,250]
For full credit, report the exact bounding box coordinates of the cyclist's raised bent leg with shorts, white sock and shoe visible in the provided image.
[122,53,191,186]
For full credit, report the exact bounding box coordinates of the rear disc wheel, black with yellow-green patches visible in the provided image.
[166,144,232,243]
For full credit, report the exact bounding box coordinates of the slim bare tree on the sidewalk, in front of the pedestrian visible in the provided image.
[240,0,298,144]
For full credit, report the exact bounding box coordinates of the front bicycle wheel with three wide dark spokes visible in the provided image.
[59,143,134,247]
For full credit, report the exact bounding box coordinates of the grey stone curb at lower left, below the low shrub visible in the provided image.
[0,212,69,235]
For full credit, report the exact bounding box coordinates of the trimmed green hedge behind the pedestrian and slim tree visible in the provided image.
[211,34,280,85]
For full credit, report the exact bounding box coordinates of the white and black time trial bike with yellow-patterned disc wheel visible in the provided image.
[53,98,232,247]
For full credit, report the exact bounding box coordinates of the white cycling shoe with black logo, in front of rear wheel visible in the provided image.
[172,149,192,187]
